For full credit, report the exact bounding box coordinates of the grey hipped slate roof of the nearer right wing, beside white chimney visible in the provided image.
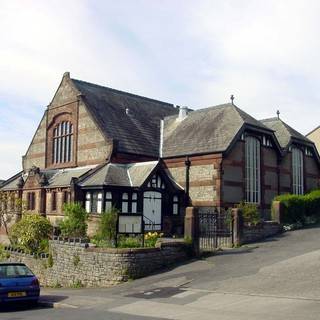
[162,103,272,157]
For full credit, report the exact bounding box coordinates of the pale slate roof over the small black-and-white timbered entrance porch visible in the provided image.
[79,161,159,187]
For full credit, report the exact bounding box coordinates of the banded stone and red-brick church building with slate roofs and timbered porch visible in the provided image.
[0,73,320,238]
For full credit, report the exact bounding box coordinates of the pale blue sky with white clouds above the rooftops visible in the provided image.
[0,0,320,179]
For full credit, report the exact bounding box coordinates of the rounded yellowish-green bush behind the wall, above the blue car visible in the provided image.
[9,214,52,253]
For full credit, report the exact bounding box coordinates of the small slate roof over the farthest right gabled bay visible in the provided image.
[261,117,313,149]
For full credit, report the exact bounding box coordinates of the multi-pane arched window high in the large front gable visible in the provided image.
[52,121,73,164]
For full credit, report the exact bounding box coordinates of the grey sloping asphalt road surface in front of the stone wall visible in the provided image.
[0,228,320,320]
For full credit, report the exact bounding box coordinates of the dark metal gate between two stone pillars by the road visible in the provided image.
[196,212,233,252]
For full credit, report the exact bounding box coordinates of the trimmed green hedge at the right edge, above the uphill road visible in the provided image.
[274,190,320,224]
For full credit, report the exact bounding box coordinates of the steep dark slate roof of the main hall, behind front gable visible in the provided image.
[71,79,178,157]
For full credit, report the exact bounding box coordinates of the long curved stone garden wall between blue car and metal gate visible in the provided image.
[6,240,188,287]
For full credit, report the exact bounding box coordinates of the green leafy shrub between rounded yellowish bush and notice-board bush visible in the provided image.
[59,202,89,238]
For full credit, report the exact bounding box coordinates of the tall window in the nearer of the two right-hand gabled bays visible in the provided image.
[245,136,260,203]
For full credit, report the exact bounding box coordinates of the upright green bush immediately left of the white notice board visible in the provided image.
[95,207,119,241]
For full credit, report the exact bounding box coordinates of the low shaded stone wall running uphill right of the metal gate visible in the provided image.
[241,221,282,244]
